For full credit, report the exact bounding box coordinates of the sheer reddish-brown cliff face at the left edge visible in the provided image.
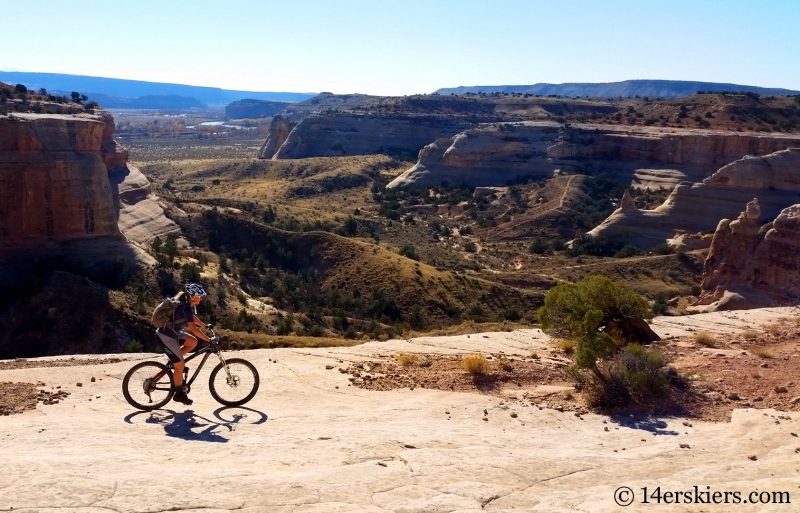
[0,114,119,247]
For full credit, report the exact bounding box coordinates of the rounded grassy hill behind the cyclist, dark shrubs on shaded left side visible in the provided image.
[188,210,542,327]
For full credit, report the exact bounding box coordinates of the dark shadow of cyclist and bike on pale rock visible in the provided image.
[125,407,268,443]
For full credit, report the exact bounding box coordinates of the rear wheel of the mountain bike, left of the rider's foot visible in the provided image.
[122,362,175,411]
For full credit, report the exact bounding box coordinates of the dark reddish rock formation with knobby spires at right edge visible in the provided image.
[695,200,800,310]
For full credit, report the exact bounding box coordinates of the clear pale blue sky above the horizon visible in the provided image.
[0,0,800,94]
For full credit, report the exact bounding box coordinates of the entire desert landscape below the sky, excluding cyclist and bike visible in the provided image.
[0,29,800,513]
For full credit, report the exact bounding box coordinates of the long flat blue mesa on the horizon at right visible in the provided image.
[438,76,800,98]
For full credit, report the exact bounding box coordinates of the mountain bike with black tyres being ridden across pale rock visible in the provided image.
[122,325,260,411]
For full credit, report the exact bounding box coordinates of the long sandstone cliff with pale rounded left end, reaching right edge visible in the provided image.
[390,122,800,187]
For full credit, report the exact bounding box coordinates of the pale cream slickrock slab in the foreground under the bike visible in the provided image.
[0,310,800,513]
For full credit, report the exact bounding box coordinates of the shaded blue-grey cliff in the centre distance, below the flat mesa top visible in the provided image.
[260,114,469,160]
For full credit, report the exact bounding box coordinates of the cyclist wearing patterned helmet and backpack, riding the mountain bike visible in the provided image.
[156,283,209,405]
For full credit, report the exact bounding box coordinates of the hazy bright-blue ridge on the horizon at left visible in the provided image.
[0,71,316,109]
